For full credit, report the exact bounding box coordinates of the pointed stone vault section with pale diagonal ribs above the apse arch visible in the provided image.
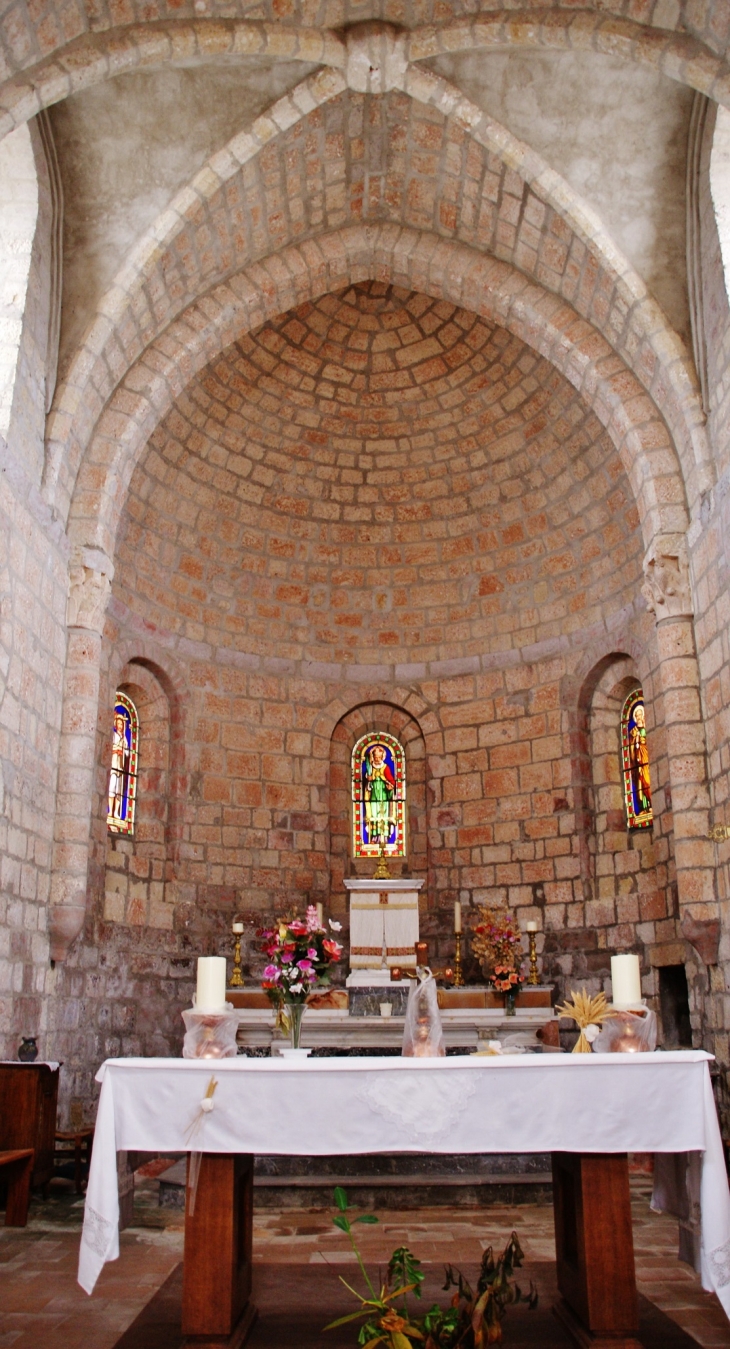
[46,67,711,526]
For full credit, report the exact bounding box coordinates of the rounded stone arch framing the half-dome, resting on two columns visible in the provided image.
[61,227,687,574]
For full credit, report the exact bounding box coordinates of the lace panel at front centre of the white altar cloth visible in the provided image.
[358,1072,476,1144]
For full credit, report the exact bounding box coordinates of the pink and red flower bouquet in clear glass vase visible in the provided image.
[259,904,343,1050]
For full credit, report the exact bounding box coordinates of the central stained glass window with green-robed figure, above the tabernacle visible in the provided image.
[352,731,406,857]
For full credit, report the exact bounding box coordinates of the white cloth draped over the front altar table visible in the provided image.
[78,1050,730,1315]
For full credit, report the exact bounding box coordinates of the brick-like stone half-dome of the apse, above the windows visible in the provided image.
[115,282,641,662]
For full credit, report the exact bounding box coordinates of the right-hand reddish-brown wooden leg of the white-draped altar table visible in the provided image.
[552,1152,641,1349]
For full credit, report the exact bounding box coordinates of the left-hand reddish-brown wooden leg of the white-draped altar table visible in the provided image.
[182,1152,256,1349]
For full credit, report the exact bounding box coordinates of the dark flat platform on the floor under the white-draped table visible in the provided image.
[115,1252,698,1349]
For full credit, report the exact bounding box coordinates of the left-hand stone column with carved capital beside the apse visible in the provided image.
[49,548,113,960]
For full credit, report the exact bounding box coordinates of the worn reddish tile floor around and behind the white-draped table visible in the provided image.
[0,1176,730,1349]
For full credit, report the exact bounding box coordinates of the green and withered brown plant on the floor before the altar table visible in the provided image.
[325,1186,537,1349]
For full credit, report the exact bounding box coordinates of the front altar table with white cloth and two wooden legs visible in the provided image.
[78,1051,730,1349]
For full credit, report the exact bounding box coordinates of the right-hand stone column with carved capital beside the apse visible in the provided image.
[642,534,718,922]
